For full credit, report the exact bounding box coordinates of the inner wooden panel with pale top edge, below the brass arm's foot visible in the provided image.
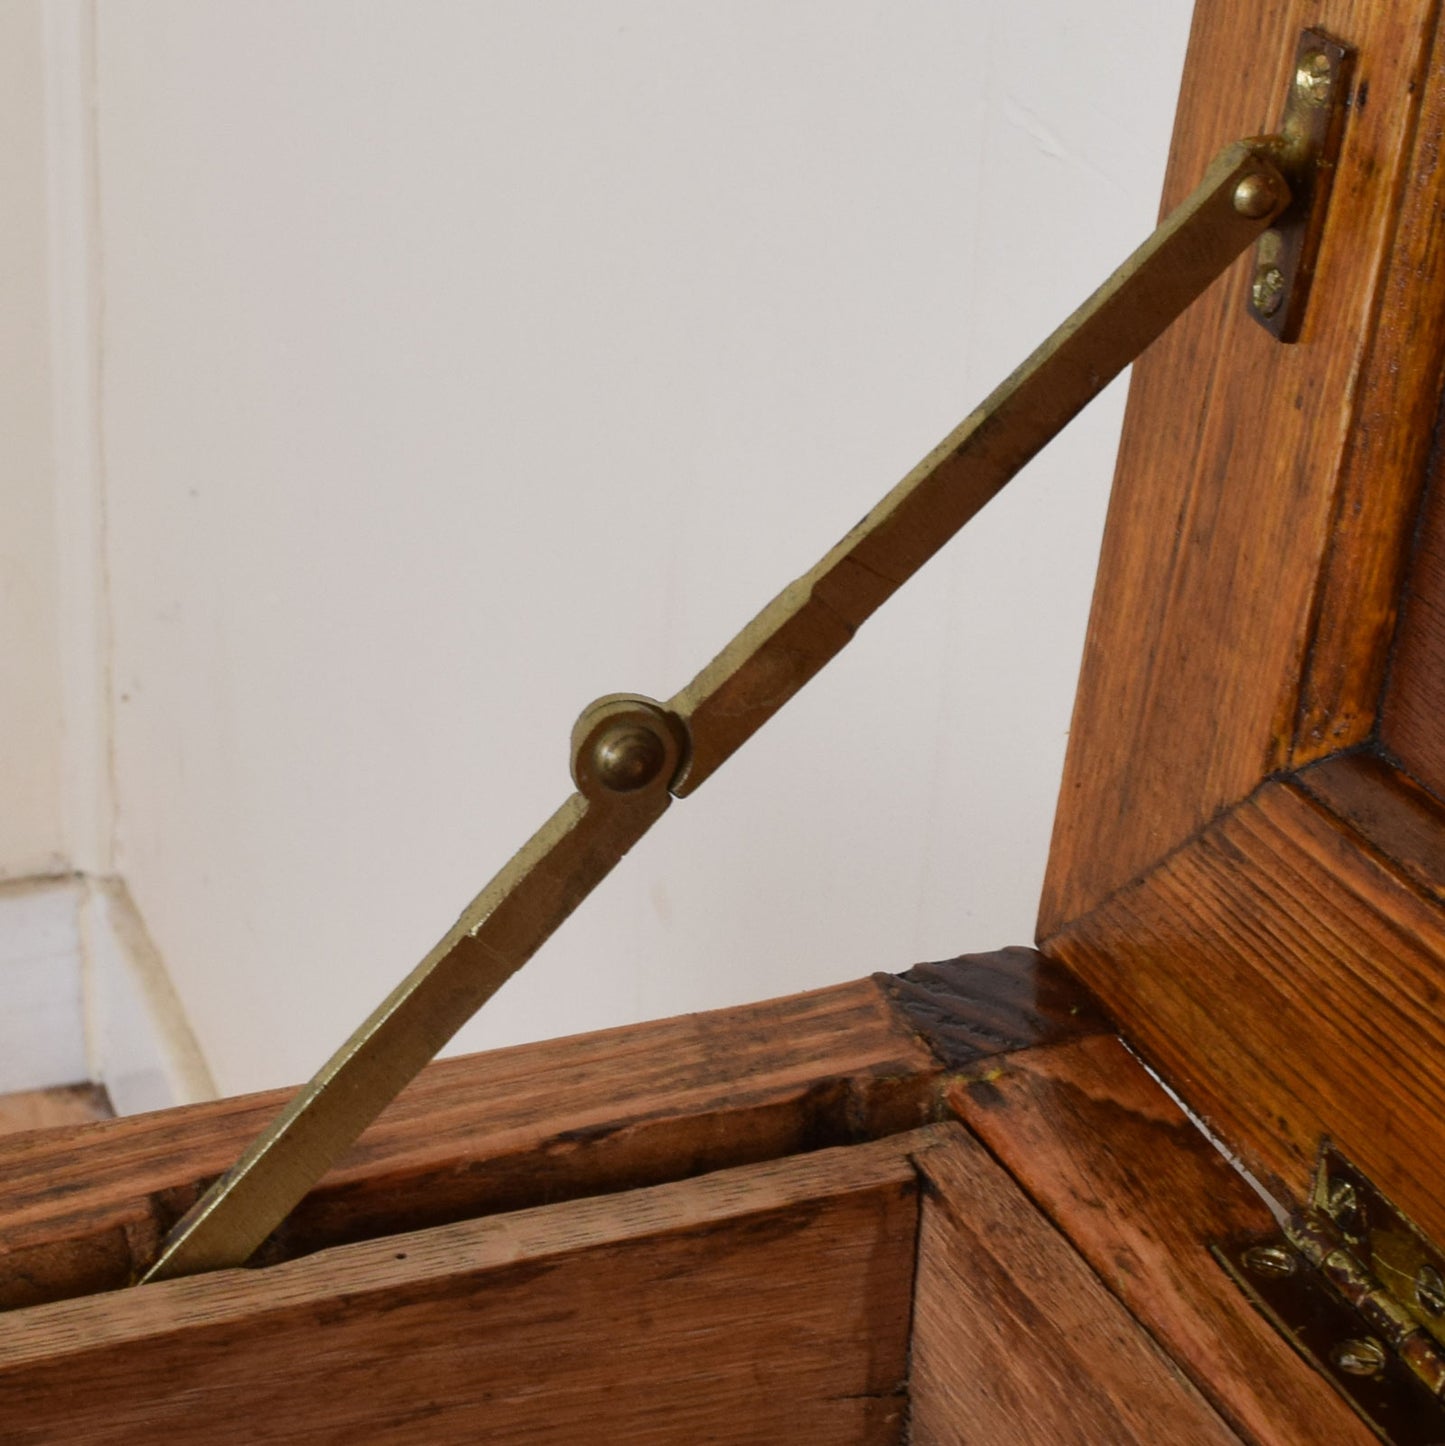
[0,1126,925,1446]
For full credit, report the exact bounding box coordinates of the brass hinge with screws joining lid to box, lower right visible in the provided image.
[1214,1141,1445,1446]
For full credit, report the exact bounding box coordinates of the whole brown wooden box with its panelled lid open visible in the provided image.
[0,0,1445,1446]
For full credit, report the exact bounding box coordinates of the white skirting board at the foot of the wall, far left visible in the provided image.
[0,873,216,1115]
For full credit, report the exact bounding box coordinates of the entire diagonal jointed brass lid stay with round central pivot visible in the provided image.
[145,137,1290,1281]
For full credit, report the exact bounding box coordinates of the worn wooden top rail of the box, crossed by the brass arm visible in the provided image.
[0,980,939,1307]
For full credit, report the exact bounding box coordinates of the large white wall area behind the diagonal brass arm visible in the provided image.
[82,0,1197,1090]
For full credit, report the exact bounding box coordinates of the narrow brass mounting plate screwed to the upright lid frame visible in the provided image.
[1250,30,1354,341]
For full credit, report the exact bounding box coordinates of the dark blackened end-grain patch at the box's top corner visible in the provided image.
[874,949,1112,1070]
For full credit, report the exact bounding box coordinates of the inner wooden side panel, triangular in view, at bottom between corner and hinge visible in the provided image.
[910,1129,1240,1446]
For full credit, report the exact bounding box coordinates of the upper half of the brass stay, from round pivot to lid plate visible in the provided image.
[668,139,1289,797]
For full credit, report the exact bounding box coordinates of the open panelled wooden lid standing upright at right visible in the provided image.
[1039,0,1445,1238]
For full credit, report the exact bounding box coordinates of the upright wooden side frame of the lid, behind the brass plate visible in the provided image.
[1040,0,1445,931]
